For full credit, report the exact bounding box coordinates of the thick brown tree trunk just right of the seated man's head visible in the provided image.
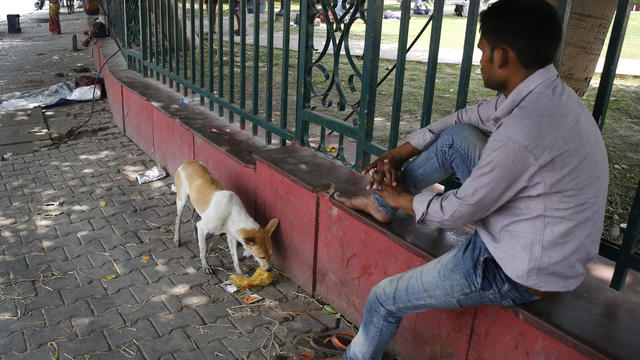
[549,0,618,97]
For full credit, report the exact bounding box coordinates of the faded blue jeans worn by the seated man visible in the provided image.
[344,125,539,360]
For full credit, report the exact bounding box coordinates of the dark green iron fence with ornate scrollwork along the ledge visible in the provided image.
[102,0,640,289]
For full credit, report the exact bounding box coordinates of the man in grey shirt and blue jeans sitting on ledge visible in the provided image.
[336,0,608,359]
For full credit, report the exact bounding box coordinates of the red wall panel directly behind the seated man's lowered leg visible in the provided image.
[315,195,473,360]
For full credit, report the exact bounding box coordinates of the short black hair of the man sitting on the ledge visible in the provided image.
[480,0,562,70]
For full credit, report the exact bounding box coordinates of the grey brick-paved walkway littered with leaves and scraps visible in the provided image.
[0,6,352,360]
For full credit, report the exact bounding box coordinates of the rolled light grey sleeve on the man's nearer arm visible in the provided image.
[413,136,535,228]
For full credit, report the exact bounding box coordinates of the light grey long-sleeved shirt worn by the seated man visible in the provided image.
[408,65,609,291]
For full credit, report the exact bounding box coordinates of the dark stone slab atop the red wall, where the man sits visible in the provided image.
[256,146,640,359]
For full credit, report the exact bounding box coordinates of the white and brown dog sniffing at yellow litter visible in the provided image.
[173,160,279,274]
